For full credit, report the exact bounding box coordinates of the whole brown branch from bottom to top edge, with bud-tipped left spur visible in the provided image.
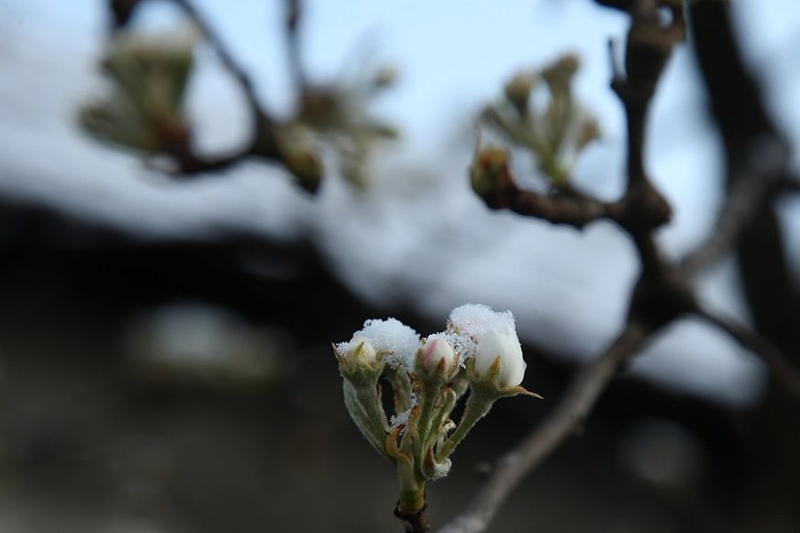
[442,0,697,533]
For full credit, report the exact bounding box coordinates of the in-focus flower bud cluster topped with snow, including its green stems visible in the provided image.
[334,304,536,514]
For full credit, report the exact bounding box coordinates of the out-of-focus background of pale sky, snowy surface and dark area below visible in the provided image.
[0,0,800,533]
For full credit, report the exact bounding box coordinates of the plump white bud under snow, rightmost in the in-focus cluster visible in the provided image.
[474,327,527,390]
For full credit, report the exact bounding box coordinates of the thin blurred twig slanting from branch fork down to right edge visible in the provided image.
[697,310,800,398]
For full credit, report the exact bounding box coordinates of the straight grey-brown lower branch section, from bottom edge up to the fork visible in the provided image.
[440,323,653,533]
